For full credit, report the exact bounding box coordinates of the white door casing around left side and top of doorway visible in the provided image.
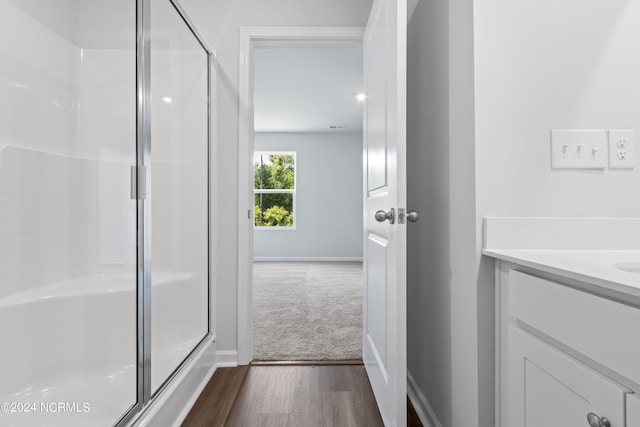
[237,27,364,365]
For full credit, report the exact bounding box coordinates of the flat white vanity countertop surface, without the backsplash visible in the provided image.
[482,249,640,297]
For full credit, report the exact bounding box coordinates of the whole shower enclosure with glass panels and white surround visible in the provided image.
[0,0,211,427]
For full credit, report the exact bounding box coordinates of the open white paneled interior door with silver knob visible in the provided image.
[362,0,407,426]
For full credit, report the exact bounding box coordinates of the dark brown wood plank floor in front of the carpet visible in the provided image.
[182,365,383,427]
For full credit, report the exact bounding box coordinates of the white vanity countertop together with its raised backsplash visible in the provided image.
[482,218,640,297]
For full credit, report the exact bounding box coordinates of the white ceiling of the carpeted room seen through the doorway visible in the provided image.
[254,42,363,132]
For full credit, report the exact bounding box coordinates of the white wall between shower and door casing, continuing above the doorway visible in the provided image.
[181,0,372,351]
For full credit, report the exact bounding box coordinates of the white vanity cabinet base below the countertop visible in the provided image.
[496,261,640,427]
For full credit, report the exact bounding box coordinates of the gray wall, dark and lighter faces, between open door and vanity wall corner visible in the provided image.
[407,0,493,427]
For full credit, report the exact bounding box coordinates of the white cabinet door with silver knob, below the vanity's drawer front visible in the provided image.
[508,325,627,427]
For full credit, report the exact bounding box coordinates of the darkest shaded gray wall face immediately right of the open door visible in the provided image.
[407,0,453,426]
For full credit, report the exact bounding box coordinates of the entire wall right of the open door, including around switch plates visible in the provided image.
[408,0,640,427]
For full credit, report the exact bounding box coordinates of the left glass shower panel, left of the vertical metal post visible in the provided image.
[0,0,137,427]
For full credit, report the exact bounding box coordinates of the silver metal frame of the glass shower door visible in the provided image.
[115,0,213,427]
